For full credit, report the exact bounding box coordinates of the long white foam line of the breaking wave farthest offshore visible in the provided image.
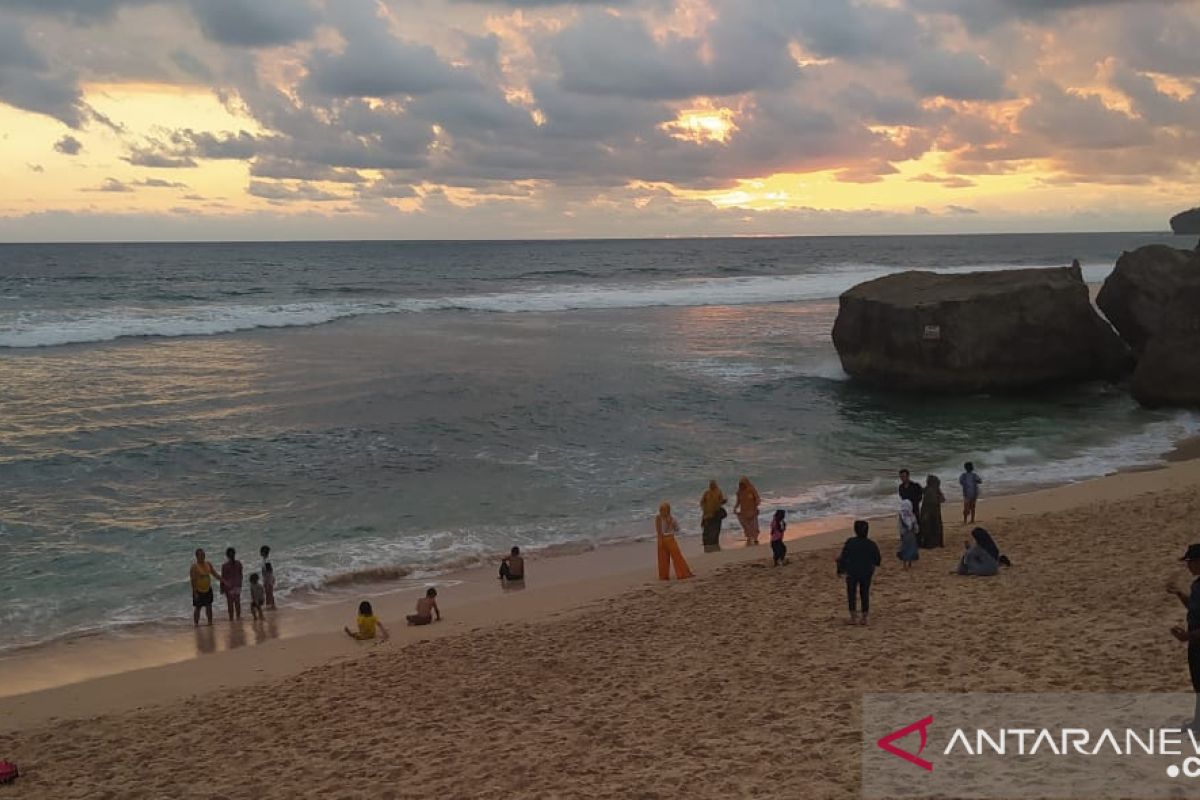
[0,265,1106,347]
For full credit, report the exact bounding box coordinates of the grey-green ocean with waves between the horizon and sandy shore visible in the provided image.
[0,234,1200,652]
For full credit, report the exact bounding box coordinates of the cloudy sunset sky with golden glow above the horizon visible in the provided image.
[0,0,1200,241]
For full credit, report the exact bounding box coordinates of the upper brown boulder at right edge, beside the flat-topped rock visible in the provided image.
[1096,245,1200,353]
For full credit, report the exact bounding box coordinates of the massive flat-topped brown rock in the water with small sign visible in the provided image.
[833,266,1133,392]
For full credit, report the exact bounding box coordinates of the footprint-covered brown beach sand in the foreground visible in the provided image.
[0,461,1200,799]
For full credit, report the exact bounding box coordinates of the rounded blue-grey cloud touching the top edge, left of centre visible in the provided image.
[180,0,316,47]
